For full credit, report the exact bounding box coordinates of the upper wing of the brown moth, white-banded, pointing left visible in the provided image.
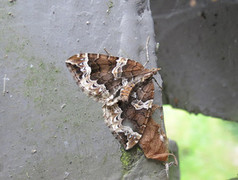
[66,53,159,105]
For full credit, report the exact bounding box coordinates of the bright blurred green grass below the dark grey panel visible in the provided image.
[164,106,238,180]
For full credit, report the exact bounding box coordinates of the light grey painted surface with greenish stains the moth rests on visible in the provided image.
[0,0,179,179]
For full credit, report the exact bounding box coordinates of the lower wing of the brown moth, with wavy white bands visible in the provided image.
[103,79,154,150]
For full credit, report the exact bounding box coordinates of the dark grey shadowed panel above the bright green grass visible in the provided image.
[151,0,238,121]
